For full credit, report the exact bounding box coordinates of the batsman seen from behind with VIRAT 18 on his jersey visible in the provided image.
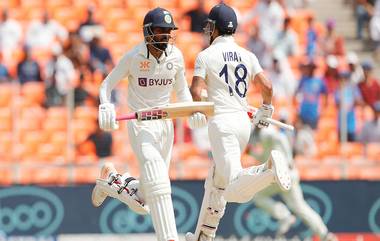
[186,3,291,241]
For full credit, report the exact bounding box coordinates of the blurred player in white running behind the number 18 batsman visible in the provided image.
[249,127,336,241]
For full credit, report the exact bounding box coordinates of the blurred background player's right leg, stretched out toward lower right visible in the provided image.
[281,178,331,240]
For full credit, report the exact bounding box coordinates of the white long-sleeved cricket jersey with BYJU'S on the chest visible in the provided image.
[100,43,192,111]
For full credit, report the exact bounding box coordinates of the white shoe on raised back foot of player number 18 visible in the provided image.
[269,150,292,191]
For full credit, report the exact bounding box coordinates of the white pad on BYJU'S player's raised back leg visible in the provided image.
[93,178,149,215]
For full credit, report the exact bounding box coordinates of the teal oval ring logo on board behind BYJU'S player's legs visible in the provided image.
[99,186,199,233]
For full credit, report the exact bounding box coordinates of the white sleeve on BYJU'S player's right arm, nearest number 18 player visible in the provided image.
[174,50,193,102]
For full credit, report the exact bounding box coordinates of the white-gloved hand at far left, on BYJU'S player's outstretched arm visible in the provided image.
[98,103,119,131]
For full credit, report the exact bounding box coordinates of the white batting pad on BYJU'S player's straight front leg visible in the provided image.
[140,144,178,241]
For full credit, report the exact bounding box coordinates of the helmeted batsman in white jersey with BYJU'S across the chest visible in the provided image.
[92,8,207,241]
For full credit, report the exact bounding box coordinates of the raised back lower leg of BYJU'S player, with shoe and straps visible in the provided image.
[91,162,149,215]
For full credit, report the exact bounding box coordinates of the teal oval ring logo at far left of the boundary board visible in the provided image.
[0,187,64,236]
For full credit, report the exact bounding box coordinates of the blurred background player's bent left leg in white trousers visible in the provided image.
[253,186,297,236]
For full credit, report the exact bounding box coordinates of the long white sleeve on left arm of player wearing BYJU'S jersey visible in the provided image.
[99,52,133,103]
